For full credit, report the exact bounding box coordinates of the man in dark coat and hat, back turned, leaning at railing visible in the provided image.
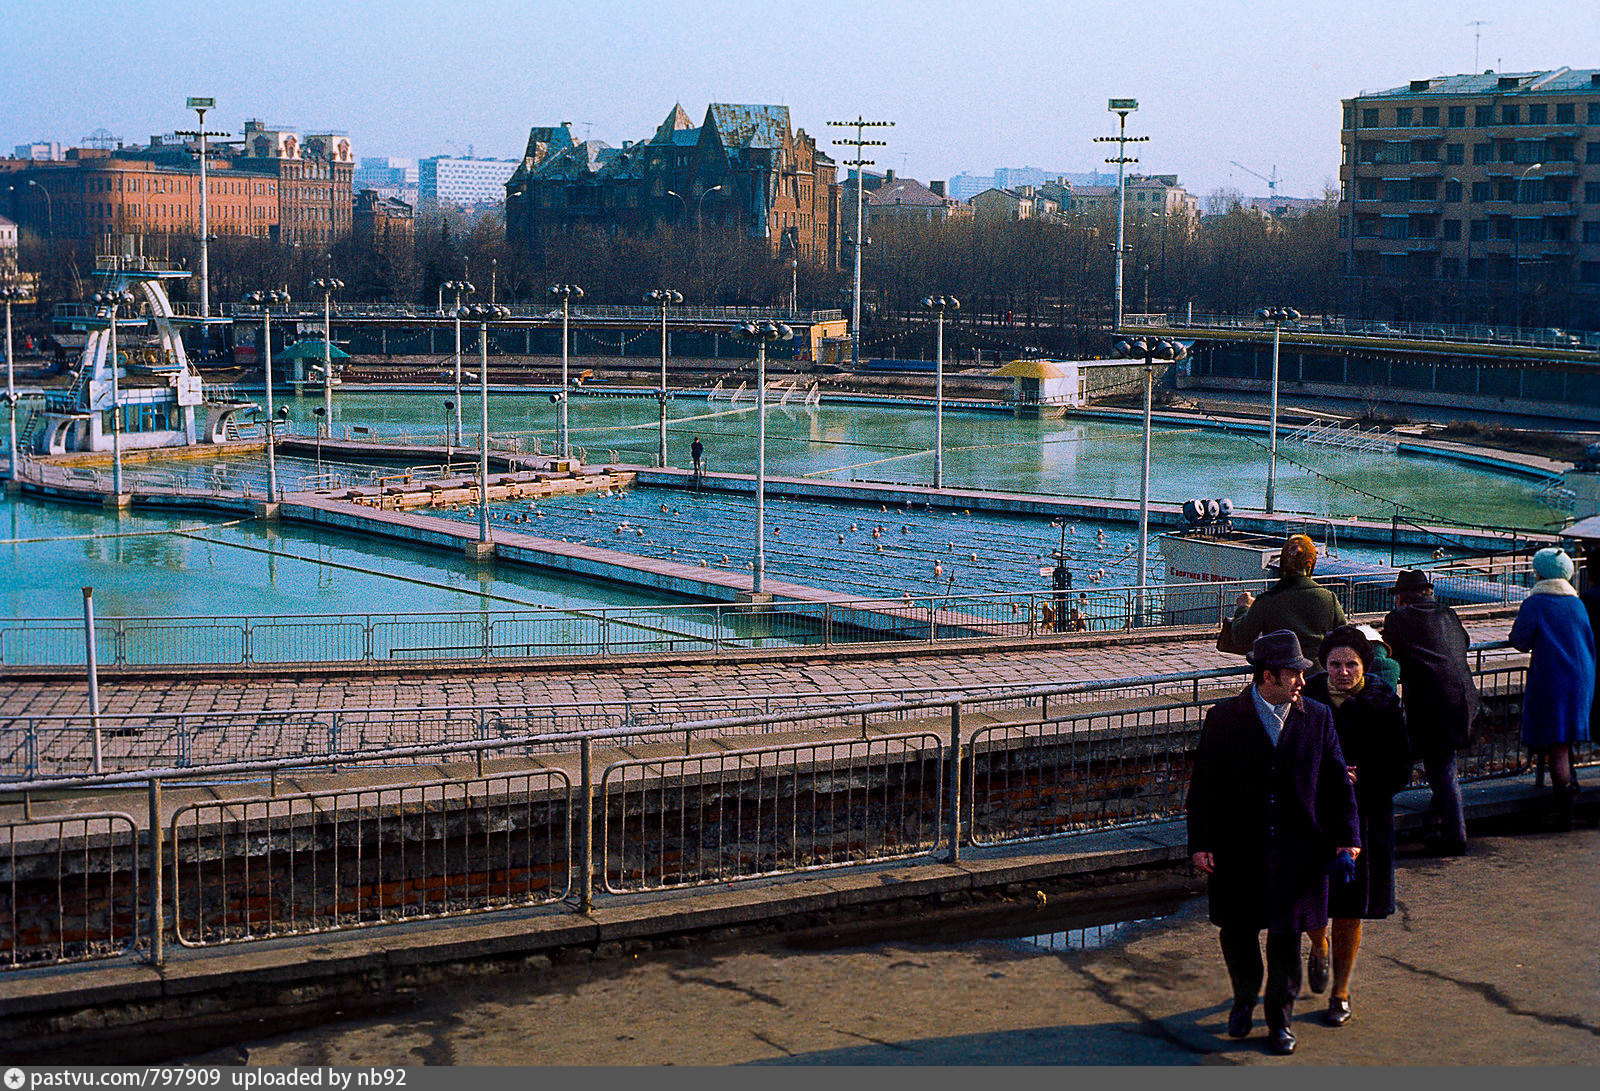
[1384,571,1478,856]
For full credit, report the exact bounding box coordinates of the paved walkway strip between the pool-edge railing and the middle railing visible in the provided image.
[0,616,1510,715]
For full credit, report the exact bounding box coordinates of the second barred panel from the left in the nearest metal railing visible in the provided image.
[170,769,573,947]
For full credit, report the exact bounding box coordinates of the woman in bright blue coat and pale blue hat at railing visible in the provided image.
[1510,547,1595,829]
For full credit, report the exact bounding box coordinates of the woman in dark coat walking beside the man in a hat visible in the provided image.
[1306,625,1411,1027]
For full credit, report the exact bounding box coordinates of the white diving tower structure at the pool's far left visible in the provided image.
[36,254,250,454]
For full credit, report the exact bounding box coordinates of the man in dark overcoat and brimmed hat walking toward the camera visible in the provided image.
[1189,629,1360,1054]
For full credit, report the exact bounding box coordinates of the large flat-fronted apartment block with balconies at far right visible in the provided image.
[1339,69,1600,326]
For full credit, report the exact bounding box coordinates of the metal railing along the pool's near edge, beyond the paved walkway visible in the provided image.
[0,572,1526,667]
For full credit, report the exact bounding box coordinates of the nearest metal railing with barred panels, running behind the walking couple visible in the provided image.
[0,649,1600,968]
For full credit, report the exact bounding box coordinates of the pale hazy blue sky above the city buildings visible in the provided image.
[0,0,1600,195]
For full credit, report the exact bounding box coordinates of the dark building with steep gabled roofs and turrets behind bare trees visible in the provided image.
[506,102,840,261]
